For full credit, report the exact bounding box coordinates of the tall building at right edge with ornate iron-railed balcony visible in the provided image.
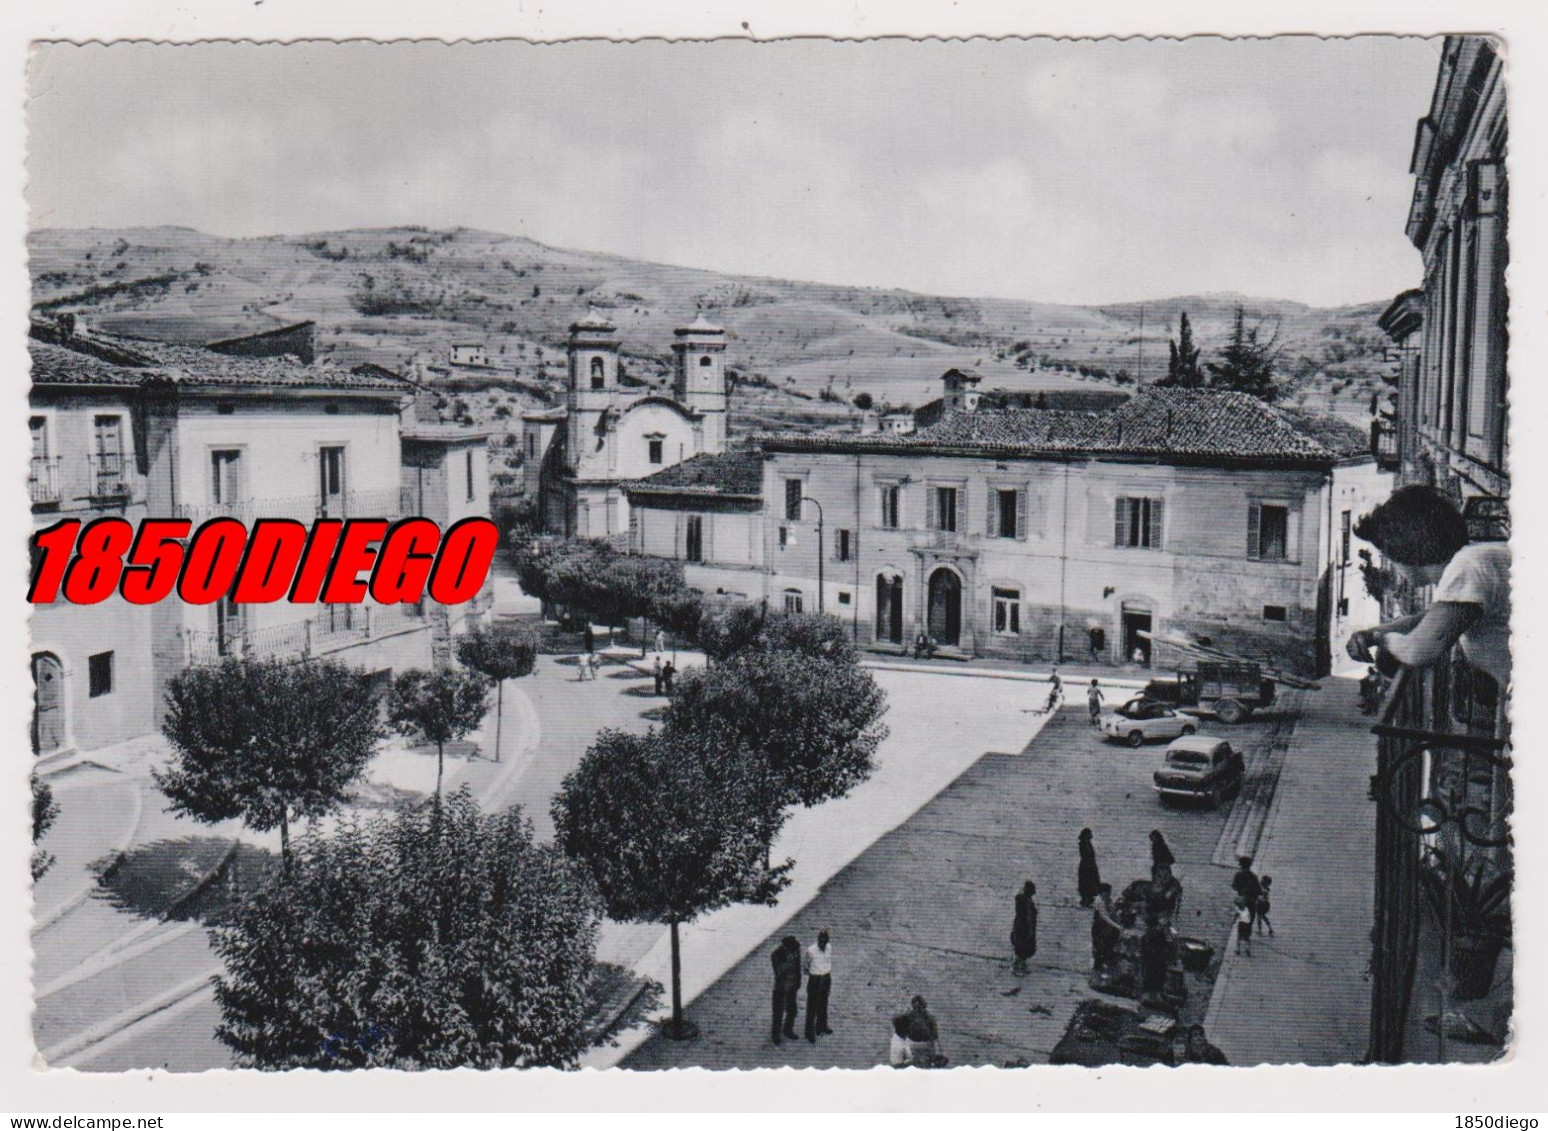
[1367,36,1514,1063]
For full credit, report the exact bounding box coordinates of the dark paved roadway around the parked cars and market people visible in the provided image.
[625,708,1276,1069]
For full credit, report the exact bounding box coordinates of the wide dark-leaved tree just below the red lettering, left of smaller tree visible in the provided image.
[152,658,382,870]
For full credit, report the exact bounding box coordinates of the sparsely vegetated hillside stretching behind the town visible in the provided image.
[28,227,1385,430]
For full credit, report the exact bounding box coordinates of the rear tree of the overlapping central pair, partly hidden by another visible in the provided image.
[666,650,887,848]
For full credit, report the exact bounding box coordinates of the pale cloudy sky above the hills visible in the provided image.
[28,37,1440,305]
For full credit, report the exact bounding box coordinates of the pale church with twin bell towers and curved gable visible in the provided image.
[522,314,726,538]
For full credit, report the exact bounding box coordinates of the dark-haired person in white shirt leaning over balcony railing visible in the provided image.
[1348,486,1511,693]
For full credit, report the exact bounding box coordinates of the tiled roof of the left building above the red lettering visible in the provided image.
[28,331,413,393]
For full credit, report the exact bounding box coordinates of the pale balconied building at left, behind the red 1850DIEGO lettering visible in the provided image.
[29,323,489,753]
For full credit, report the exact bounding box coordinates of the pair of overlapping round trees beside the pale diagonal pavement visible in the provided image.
[553,607,887,1037]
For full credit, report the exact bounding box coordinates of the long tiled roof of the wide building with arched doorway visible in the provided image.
[763,390,1368,464]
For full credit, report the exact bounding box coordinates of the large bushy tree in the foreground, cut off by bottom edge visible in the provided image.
[215,788,598,1069]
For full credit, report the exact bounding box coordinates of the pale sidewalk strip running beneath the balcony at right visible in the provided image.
[1206,679,1376,1064]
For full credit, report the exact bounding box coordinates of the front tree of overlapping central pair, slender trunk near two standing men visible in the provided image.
[553,730,788,1038]
